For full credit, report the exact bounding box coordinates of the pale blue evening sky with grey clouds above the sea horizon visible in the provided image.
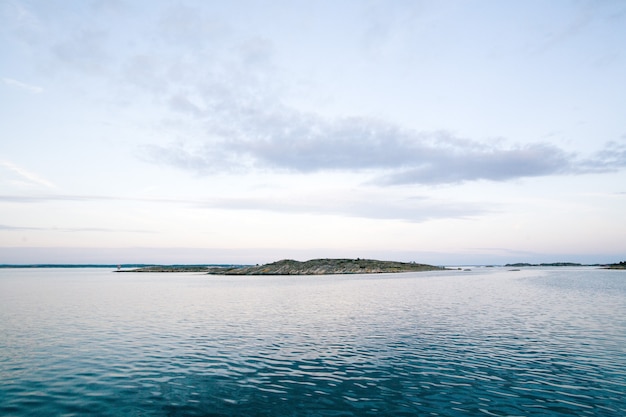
[0,0,626,265]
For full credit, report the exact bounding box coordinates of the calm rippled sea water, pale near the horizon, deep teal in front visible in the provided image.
[0,268,626,417]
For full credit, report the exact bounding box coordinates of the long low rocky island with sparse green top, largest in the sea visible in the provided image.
[119,258,447,275]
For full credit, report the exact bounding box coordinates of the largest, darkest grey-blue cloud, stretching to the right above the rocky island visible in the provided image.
[145,106,600,185]
